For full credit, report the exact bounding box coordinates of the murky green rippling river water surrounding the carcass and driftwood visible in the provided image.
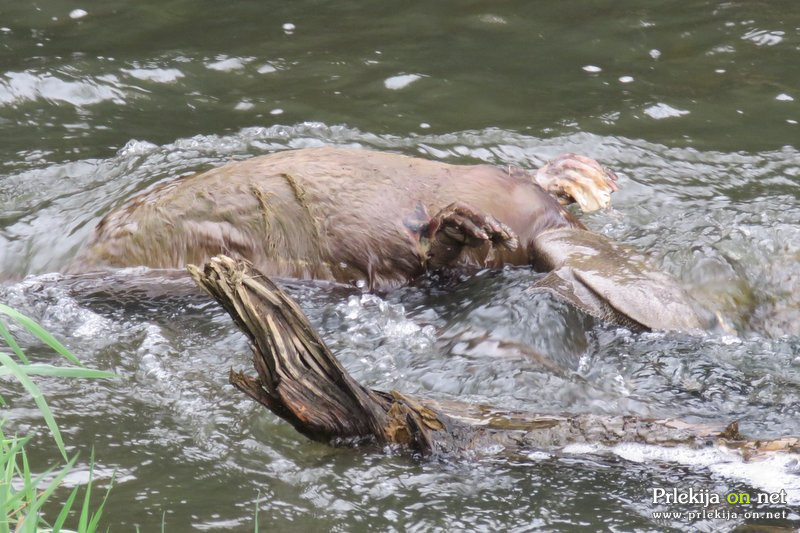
[0,0,800,531]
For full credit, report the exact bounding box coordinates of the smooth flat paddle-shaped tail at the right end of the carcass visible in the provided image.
[532,228,713,331]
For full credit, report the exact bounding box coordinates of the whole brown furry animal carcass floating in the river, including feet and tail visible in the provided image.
[72,148,701,330]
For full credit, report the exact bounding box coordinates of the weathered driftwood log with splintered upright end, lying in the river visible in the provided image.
[188,256,800,458]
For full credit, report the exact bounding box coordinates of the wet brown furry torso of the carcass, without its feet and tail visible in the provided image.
[71,148,583,288]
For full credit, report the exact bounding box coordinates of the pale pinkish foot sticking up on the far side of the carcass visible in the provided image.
[536,154,619,212]
